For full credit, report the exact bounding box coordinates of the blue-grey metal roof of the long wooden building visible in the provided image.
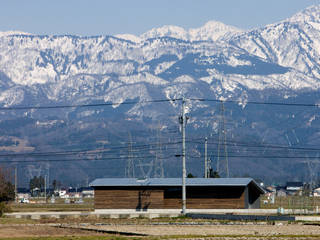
[89,178,264,193]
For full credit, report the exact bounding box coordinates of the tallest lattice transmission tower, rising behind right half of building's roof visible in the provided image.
[217,101,229,177]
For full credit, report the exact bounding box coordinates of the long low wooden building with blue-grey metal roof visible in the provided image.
[90,178,264,210]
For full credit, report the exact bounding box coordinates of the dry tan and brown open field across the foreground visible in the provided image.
[0,218,320,240]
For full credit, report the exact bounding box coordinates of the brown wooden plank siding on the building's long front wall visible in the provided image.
[94,187,245,209]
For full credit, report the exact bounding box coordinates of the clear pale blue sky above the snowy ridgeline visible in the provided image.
[0,0,320,36]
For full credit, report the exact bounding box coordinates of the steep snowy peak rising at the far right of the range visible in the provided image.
[230,6,320,79]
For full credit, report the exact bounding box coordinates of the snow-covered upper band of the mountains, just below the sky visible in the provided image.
[0,6,320,99]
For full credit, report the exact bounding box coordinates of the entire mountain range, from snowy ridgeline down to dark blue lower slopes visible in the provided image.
[0,5,320,187]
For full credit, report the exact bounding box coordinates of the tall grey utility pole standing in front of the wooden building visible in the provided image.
[180,98,186,214]
